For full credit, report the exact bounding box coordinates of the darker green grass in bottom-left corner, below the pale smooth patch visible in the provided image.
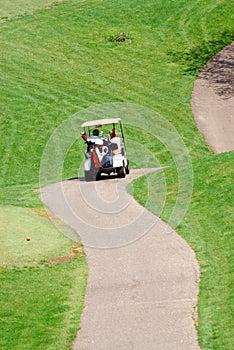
[0,258,86,350]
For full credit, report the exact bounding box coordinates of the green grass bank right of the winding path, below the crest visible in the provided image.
[130,152,234,349]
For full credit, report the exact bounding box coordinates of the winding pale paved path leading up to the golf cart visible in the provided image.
[41,169,199,350]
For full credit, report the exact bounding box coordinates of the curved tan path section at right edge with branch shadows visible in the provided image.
[191,42,234,153]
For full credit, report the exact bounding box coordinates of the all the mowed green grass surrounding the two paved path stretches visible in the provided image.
[0,0,234,350]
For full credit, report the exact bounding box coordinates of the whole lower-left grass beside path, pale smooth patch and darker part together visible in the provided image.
[0,206,87,350]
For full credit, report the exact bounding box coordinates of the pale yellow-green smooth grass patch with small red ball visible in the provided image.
[0,206,78,266]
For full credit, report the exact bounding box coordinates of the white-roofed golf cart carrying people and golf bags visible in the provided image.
[81,118,129,181]
